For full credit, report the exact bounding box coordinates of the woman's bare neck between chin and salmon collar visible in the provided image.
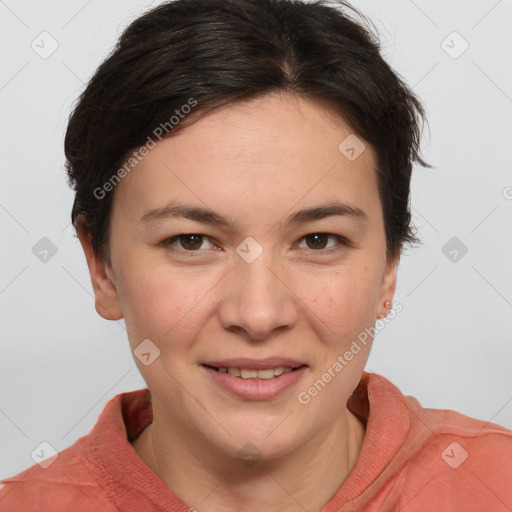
[132,404,364,512]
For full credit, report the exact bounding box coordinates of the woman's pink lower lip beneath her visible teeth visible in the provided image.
[202,365,307,400]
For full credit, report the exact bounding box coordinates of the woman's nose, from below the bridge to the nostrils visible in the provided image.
[219,253,299,340]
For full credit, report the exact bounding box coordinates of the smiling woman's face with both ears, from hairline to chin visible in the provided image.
[86,94,396,458]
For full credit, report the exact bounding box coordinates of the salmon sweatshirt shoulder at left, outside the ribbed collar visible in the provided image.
[0,438,117,512]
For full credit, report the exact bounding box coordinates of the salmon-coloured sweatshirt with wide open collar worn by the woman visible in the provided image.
[0,373,512,512]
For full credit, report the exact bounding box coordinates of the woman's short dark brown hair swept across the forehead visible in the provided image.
[65,0,428,262]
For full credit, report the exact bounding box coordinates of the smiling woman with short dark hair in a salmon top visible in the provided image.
[0,0,512,512]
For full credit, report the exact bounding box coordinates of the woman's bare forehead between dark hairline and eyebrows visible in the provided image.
[116,94,377,224]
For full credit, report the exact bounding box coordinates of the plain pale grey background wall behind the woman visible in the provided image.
[0,0,512,477]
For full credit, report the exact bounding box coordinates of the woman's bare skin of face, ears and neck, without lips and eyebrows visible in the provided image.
[79,94,397,512]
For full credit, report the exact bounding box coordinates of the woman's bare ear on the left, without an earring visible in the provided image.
[77,224,123,320]
